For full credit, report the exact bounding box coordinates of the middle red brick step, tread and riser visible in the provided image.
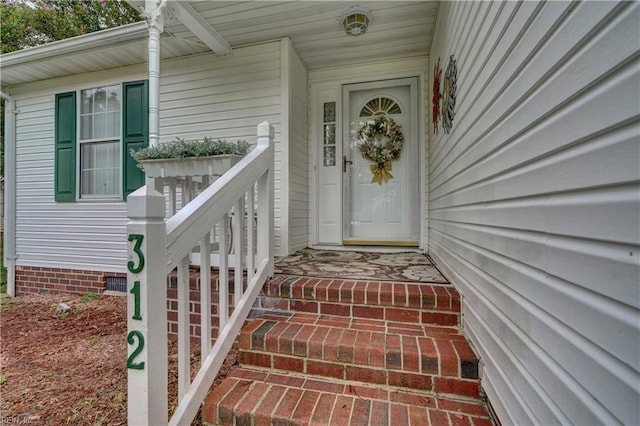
[239,313,480,397]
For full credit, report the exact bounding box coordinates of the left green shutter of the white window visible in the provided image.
[54,92,76,202]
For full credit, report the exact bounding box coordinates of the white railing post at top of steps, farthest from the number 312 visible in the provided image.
[257,121,274,276]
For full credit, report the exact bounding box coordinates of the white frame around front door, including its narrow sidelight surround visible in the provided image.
[309,70,428,252]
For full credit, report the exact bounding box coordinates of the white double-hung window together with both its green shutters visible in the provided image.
[55,81,149,202]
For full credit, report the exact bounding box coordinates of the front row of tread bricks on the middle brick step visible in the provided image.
[238,320,478,379]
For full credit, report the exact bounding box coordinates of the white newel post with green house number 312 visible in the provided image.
[127,185,168,425]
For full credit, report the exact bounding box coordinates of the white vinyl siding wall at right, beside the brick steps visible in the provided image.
[429,2,640,424]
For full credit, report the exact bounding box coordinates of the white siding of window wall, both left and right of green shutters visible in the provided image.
[13,41,282,272]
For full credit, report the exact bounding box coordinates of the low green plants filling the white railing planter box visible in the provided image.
[130,137,249,167]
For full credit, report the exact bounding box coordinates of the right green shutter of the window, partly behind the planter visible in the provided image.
[122,80,149,200]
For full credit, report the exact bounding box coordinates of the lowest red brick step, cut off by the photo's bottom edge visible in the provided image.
[203,368,492,426]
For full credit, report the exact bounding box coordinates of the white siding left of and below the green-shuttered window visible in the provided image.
[16,95,127,271]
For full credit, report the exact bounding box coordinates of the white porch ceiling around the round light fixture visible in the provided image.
[165,1,438,69]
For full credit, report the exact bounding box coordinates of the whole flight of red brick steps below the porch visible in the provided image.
[203,276,491,426]
